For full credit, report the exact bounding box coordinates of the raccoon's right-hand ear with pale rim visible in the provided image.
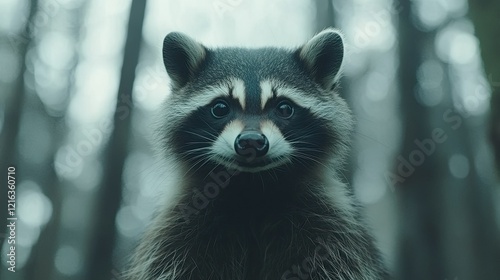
[298,28,344,90]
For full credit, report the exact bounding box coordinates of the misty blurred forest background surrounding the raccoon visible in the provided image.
[0,0,500,280]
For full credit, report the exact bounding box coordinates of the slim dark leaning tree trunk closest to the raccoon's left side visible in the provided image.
[85,0,146,280]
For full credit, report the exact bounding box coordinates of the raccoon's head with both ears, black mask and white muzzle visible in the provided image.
[159,29,352,172]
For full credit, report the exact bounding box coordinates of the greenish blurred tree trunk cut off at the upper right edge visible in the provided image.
[469,0,500,175]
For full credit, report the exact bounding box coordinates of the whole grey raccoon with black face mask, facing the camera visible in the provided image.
[128,29,389,280]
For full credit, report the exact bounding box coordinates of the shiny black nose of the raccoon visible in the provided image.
[234,131,269,160]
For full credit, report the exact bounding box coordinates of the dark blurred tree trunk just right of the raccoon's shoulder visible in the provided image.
[395,0,446,280]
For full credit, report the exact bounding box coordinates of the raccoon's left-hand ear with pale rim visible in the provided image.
[163,32,207,88]
